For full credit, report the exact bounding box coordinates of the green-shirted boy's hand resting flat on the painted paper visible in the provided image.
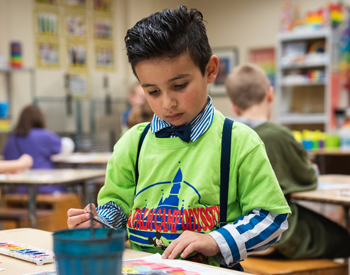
[162,231,220,259]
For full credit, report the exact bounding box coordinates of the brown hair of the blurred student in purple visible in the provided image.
[14,105,45,136]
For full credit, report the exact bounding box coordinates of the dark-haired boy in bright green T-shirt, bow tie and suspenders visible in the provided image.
[68,6,290,270]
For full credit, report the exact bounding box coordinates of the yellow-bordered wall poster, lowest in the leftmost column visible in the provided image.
[35,39,60,69]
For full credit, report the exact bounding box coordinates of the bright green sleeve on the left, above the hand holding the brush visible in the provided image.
[97,123,148,217]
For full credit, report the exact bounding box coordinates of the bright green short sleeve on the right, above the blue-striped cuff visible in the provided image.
[238,142,291,215]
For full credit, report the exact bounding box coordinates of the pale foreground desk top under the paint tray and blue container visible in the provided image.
[0,228,248,275]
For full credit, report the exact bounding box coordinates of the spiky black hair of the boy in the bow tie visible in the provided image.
[125,6,212,77]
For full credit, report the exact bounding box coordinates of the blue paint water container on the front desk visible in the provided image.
[53,228,126,275]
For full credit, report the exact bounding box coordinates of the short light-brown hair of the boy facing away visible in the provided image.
[225,63,271,111]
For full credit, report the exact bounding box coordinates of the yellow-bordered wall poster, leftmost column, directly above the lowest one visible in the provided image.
[35,11,59,36]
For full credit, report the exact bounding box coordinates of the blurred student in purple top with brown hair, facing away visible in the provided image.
[3,105,72,193]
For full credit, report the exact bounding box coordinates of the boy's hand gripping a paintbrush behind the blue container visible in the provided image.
[67,203,102,229]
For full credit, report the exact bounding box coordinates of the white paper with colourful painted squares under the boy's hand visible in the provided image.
[122,253,232,275]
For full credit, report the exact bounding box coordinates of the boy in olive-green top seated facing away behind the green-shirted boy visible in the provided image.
[225,64,350,259]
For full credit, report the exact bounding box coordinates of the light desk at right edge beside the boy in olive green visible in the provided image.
[291,175,350,232]
